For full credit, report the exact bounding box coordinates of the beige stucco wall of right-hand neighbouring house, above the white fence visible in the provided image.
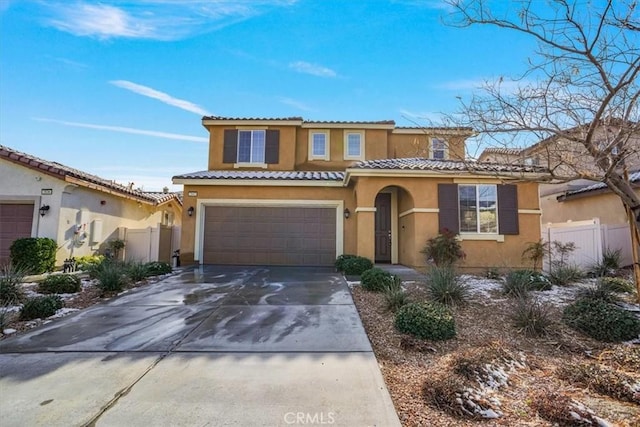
[540,189,640,225]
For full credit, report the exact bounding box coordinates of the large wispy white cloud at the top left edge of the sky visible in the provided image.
[43,0,297,40]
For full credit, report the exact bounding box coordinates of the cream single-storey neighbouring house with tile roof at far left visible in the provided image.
[0,145,182,265]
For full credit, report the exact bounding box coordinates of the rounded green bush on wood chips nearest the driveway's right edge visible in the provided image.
[395,302,456,341]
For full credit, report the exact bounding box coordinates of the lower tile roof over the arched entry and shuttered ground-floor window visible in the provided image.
[350,157,548,173]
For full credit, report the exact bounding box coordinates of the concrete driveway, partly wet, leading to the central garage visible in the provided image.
[0,266,400,426]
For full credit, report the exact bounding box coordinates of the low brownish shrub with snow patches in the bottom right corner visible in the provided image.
[558,363,640,403]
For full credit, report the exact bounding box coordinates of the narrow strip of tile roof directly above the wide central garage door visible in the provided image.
[173,170,344,181]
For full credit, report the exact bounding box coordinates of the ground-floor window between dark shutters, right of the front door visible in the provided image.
[458,184,498,234]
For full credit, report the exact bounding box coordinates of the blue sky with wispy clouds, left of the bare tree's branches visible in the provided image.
[0,0,534,191]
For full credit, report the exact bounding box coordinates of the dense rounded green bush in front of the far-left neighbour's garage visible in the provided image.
[9,237,58,274]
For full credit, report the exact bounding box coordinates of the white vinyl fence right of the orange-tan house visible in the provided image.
[542,218,633,269]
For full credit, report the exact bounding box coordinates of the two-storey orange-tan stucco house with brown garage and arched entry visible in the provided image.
[173,117,542,269]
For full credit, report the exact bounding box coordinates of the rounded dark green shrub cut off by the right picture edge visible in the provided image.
[563,297,640,342]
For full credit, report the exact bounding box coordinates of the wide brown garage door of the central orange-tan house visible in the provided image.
[202,206,336,265]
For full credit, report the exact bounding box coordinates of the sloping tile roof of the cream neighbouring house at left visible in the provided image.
[0,145,182,205]
